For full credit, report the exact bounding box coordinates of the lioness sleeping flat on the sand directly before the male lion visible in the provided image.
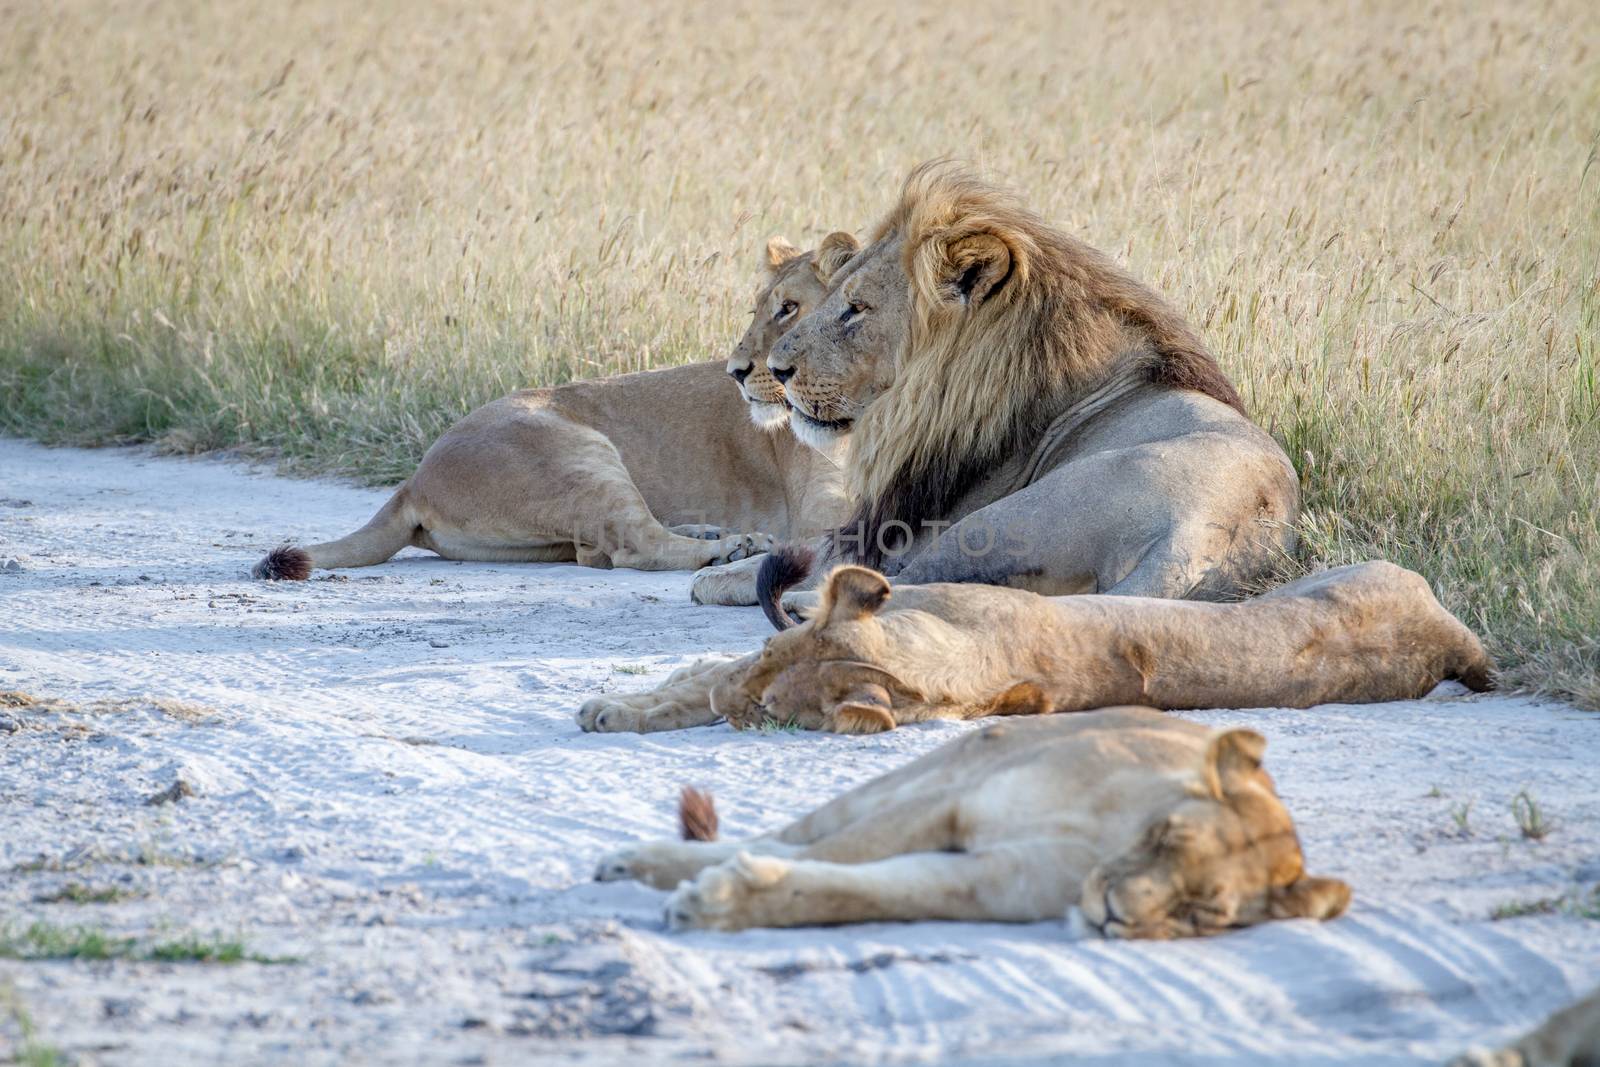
[578,550,1491,733]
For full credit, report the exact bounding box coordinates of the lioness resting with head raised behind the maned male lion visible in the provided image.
[253,238,846,579]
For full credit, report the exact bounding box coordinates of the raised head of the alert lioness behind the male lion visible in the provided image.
[728,234,856,430]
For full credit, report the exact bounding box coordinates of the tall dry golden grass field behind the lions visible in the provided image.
[0,0,1600,705]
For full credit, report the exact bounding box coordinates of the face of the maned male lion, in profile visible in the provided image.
[768,234,910,448]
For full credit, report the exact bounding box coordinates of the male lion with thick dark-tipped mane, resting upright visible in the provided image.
[768,163,1299,598]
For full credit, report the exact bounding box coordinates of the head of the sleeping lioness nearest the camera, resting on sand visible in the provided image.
[1080,729,1350,939]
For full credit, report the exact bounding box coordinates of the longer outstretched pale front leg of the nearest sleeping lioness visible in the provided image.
[667,846,1077,929]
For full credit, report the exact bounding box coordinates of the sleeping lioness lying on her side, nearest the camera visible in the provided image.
[595,707,1350,937]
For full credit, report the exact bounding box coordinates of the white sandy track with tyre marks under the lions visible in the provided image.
[0,440,1600,1064]
